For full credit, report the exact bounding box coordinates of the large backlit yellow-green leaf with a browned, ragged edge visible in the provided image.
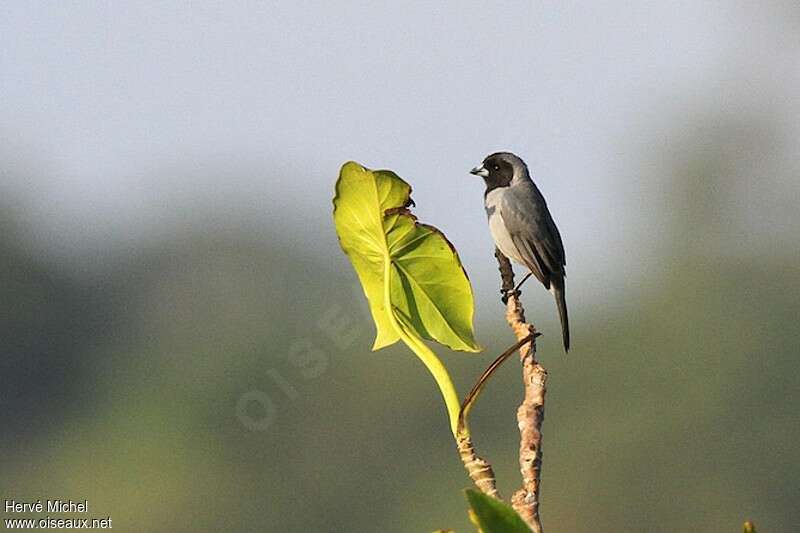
[333,161,480,352]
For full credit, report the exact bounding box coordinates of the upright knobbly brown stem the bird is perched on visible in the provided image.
[495,249,547,533]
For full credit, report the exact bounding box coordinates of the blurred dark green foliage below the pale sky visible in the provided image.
[0,147,800,533]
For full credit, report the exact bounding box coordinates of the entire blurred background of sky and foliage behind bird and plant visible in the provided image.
[0,1,800,533]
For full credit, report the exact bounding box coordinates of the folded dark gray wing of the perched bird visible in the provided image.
[500,182,566,288]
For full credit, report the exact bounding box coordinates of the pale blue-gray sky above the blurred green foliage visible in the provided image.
[0,1,800,316]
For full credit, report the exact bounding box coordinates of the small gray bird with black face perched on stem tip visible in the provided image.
[470,152,569,351]
